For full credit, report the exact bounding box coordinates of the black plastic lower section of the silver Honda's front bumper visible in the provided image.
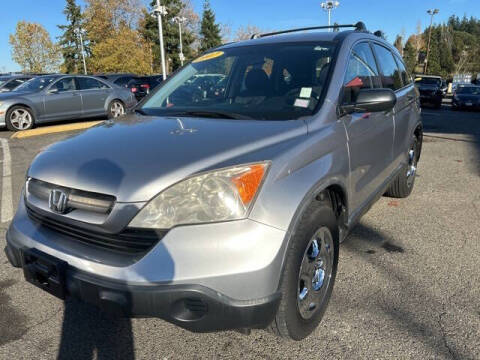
[5,243,280,332]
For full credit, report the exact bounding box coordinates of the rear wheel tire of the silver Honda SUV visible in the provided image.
[385,136,420,198]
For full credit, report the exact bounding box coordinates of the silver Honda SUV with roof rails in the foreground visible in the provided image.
[6,23,422,340]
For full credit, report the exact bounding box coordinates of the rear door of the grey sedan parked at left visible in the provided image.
[77,77,110,117]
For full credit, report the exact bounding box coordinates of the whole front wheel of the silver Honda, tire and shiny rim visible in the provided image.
[270,194,339,340]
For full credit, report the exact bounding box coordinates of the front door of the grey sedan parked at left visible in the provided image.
[44,77,82,120]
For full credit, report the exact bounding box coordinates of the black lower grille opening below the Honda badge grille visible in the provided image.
[27,205,167,254]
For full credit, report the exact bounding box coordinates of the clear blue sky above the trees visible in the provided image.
[0,0,480,72]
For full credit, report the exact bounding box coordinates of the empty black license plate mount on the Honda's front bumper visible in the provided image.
[22,249,67,299]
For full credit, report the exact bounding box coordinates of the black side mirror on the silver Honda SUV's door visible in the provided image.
[341,89,397,114]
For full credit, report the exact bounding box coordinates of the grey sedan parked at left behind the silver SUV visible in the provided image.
[0,75,136,131]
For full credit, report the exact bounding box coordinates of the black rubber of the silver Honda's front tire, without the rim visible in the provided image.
[269,194,339,340]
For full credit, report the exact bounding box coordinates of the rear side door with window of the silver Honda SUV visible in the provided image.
[373,44,415,171]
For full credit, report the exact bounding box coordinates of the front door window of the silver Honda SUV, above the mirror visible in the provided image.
[343,43,382,104]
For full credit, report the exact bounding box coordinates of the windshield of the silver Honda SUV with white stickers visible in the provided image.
[141,42,334,120]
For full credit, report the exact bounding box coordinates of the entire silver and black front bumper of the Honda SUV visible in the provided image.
[7,201,285,331]
